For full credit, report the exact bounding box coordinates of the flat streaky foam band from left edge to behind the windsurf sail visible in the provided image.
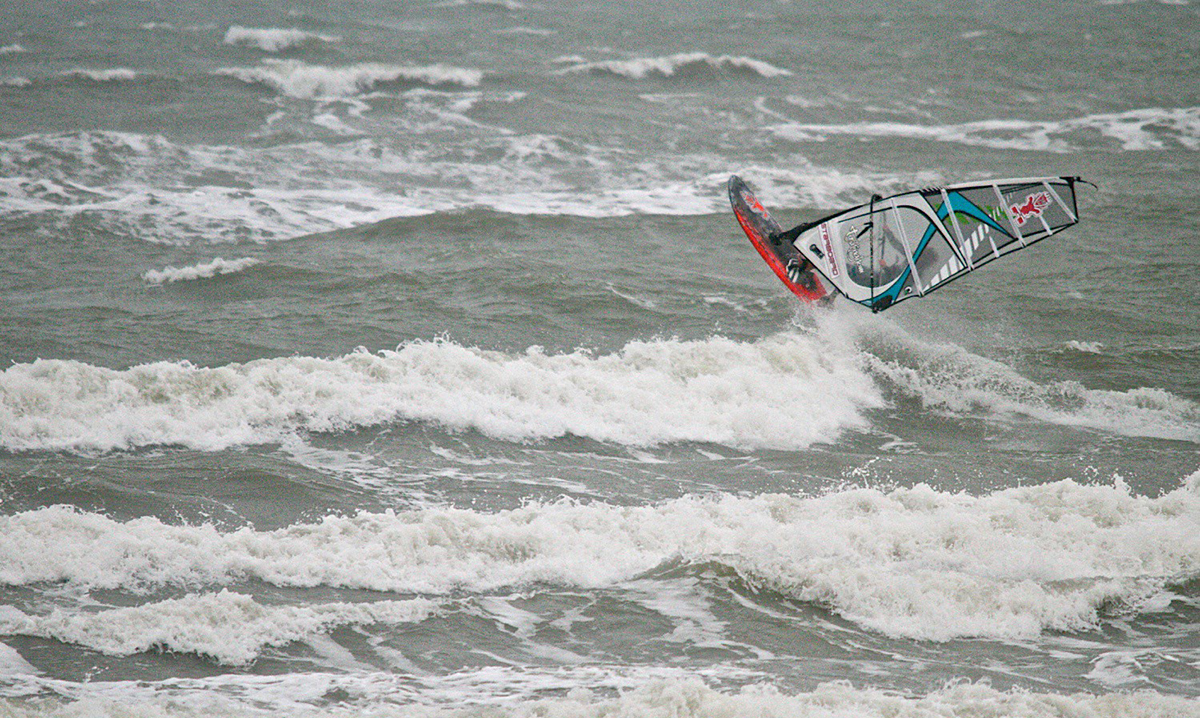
[0,133,907,244]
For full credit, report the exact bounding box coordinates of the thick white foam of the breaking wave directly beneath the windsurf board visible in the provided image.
[0,309,1200,451]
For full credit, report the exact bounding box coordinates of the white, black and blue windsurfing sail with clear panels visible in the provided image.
[792,176,1082,312]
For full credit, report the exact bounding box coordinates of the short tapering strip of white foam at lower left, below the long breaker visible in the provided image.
[0,590,437,665]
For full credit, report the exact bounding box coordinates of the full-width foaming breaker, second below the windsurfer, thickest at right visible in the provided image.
[0,478,1200,641]
